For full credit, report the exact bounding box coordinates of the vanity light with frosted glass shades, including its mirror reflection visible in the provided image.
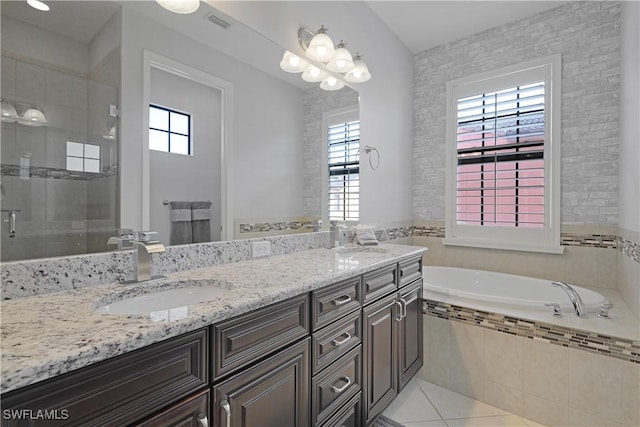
[280,25,371,90]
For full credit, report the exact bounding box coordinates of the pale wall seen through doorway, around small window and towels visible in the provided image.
[149,68,222,245]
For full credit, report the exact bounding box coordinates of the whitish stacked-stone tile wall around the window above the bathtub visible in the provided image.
[412,1,621,225]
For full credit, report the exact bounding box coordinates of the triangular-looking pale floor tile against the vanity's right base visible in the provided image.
[382,379,442,424]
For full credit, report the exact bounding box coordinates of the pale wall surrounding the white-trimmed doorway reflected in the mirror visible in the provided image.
[120,7,303,232]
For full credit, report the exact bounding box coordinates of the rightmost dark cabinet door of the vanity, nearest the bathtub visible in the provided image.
[398,279,423,391]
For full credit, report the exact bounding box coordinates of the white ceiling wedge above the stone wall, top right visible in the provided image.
[366,0,567,54]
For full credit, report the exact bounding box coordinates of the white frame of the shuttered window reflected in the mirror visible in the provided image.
[322,105,361,224]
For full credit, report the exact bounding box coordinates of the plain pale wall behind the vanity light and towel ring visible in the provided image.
[212,1,413,224]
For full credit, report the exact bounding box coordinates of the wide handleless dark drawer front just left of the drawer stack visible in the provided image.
[212,294,309,379]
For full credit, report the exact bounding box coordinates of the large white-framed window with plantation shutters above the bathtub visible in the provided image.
[445,57,561,252]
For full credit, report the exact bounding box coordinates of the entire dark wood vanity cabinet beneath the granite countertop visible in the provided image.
[2,258,422,427]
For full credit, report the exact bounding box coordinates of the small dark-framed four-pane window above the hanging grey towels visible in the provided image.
[149,105,192,155]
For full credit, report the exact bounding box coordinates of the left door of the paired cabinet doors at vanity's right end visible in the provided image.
[363,292,400,424]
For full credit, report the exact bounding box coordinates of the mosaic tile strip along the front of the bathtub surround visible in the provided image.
[422,300,640,364]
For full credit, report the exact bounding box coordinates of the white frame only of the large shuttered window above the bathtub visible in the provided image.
[443,54,563,253]
